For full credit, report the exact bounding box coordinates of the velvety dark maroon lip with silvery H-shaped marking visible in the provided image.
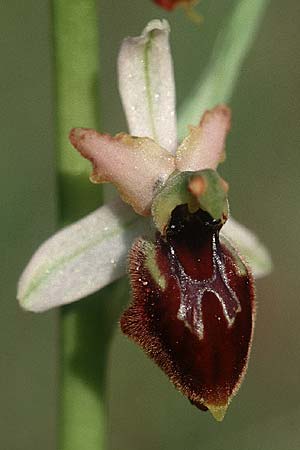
[121,205,255,417]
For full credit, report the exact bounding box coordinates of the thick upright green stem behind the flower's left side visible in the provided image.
[53,0,116,450]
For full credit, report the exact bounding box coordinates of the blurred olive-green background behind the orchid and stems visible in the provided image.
[0,0,300,450]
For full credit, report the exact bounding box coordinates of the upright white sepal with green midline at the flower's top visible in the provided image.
[118,20,177,153]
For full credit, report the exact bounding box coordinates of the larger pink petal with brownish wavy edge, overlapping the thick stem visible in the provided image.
[70,128,175,215]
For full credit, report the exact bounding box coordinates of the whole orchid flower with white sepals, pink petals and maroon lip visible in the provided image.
[18,20,271,420]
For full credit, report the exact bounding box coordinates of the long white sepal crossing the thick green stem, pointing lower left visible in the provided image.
[17,200,149,312]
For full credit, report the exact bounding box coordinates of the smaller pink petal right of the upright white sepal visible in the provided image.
[176,105,231,172]
